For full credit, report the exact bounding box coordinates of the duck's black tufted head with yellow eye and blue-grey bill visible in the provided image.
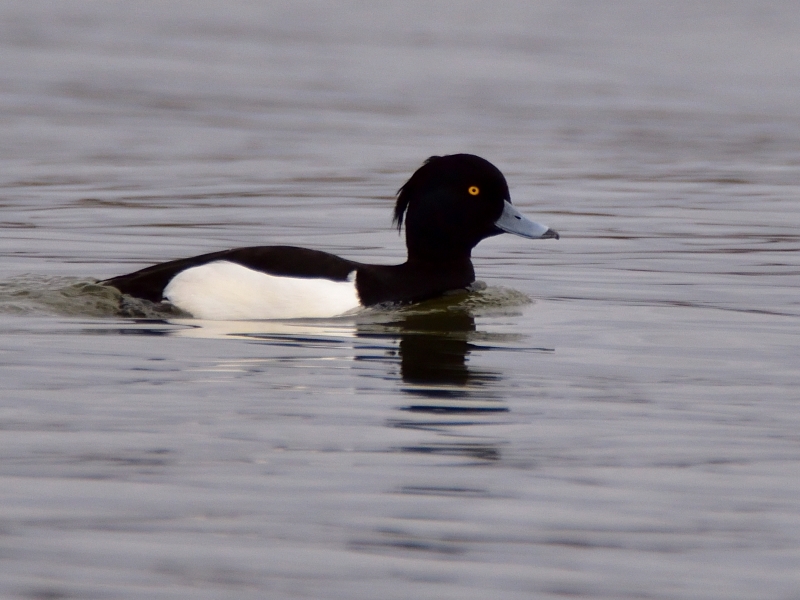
[394,154,558,260]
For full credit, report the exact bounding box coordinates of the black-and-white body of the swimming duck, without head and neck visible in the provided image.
[104,246,482,320]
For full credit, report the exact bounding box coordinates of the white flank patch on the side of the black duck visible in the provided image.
[164,261,361,321]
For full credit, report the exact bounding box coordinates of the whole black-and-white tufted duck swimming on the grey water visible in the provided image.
[100,154,559,320]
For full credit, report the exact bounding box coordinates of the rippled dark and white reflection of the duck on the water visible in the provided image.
[117,307,518,462]
